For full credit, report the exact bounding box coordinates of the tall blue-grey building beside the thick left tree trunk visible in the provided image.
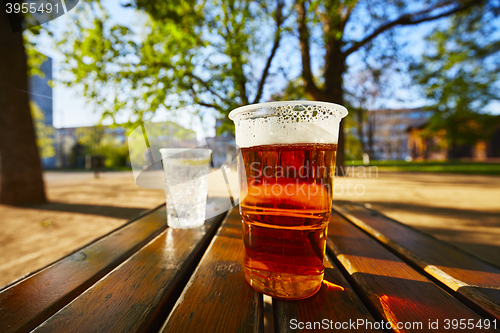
[28,58,56,169]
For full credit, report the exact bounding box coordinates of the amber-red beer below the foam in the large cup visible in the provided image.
[240,143,337,299]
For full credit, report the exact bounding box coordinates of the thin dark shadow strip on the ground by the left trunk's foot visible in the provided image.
[23,202,148,220]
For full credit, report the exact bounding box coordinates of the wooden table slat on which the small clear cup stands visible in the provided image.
[34,204,224,332]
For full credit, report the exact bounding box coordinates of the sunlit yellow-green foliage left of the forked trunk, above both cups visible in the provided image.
[52,0,288,129]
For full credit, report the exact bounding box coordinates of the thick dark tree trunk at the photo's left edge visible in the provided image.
[0,13,47,205]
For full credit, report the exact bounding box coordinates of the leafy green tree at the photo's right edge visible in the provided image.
[413,4,500,158]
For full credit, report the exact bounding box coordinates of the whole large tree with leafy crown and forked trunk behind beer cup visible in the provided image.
[53,0,485,171]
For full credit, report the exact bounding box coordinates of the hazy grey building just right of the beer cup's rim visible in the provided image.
[363,108,432,160]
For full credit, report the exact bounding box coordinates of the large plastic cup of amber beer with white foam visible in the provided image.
[229,101,347,299]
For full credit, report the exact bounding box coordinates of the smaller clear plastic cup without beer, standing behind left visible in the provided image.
[160,148,212,229]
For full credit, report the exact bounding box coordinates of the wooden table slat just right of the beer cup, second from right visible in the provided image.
[327,214,492,332]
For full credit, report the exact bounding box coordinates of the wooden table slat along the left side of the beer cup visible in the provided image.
[162,209,263,333]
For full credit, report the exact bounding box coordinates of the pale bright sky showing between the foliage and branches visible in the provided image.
[33,1,500,130]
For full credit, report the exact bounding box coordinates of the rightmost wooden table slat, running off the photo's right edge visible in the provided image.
[334,204,500,321]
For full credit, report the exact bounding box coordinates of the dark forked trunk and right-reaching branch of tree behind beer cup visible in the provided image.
[296,0,484,166]
